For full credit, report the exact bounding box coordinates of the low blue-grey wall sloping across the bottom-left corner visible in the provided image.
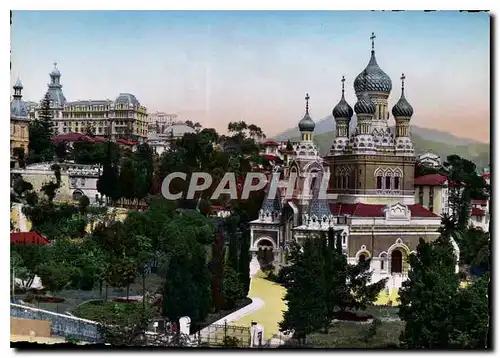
[10,303,102,343]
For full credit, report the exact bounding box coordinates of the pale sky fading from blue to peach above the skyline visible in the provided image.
[11,11,490,142]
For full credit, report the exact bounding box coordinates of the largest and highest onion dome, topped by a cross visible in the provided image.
[354,33,392,94]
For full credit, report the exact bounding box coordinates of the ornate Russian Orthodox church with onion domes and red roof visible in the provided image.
[250,34,458,288]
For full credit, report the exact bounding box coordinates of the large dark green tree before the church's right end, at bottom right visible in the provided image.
[398,236,460,349]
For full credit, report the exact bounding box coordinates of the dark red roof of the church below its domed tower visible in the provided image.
[330,203,438,218]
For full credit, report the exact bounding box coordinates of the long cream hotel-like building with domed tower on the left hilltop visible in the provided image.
[29,63,148,141]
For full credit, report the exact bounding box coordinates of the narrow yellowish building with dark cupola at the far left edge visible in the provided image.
[10,79,30,157]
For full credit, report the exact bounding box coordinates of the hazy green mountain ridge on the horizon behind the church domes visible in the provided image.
[274,115,490,170]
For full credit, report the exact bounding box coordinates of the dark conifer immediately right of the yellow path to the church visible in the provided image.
[279,238,329,344]
